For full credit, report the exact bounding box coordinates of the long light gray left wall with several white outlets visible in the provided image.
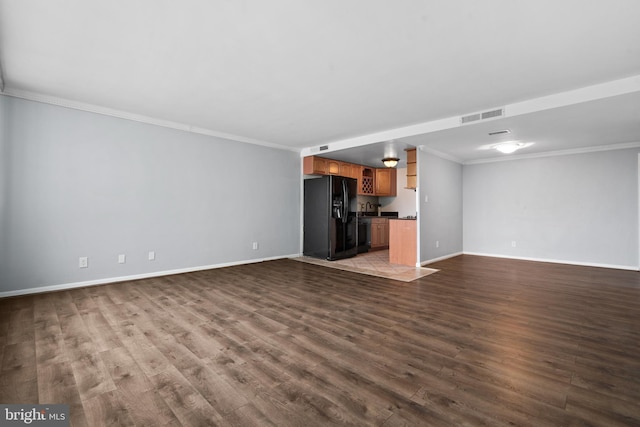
[0,96,301,292]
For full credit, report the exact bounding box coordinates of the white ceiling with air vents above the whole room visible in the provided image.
[0,0,640,162]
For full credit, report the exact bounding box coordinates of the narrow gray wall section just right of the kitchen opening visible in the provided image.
[418,150,462,263]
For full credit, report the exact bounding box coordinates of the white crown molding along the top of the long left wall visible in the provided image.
[0,88,300,153]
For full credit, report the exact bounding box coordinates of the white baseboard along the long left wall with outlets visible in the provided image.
[0,254,301,298]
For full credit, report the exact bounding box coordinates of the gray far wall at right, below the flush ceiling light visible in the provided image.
[463,149,639,268]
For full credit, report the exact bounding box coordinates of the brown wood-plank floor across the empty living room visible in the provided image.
[0,256,640,427]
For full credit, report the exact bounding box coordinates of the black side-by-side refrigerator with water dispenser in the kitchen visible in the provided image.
[303,175,358,261]
